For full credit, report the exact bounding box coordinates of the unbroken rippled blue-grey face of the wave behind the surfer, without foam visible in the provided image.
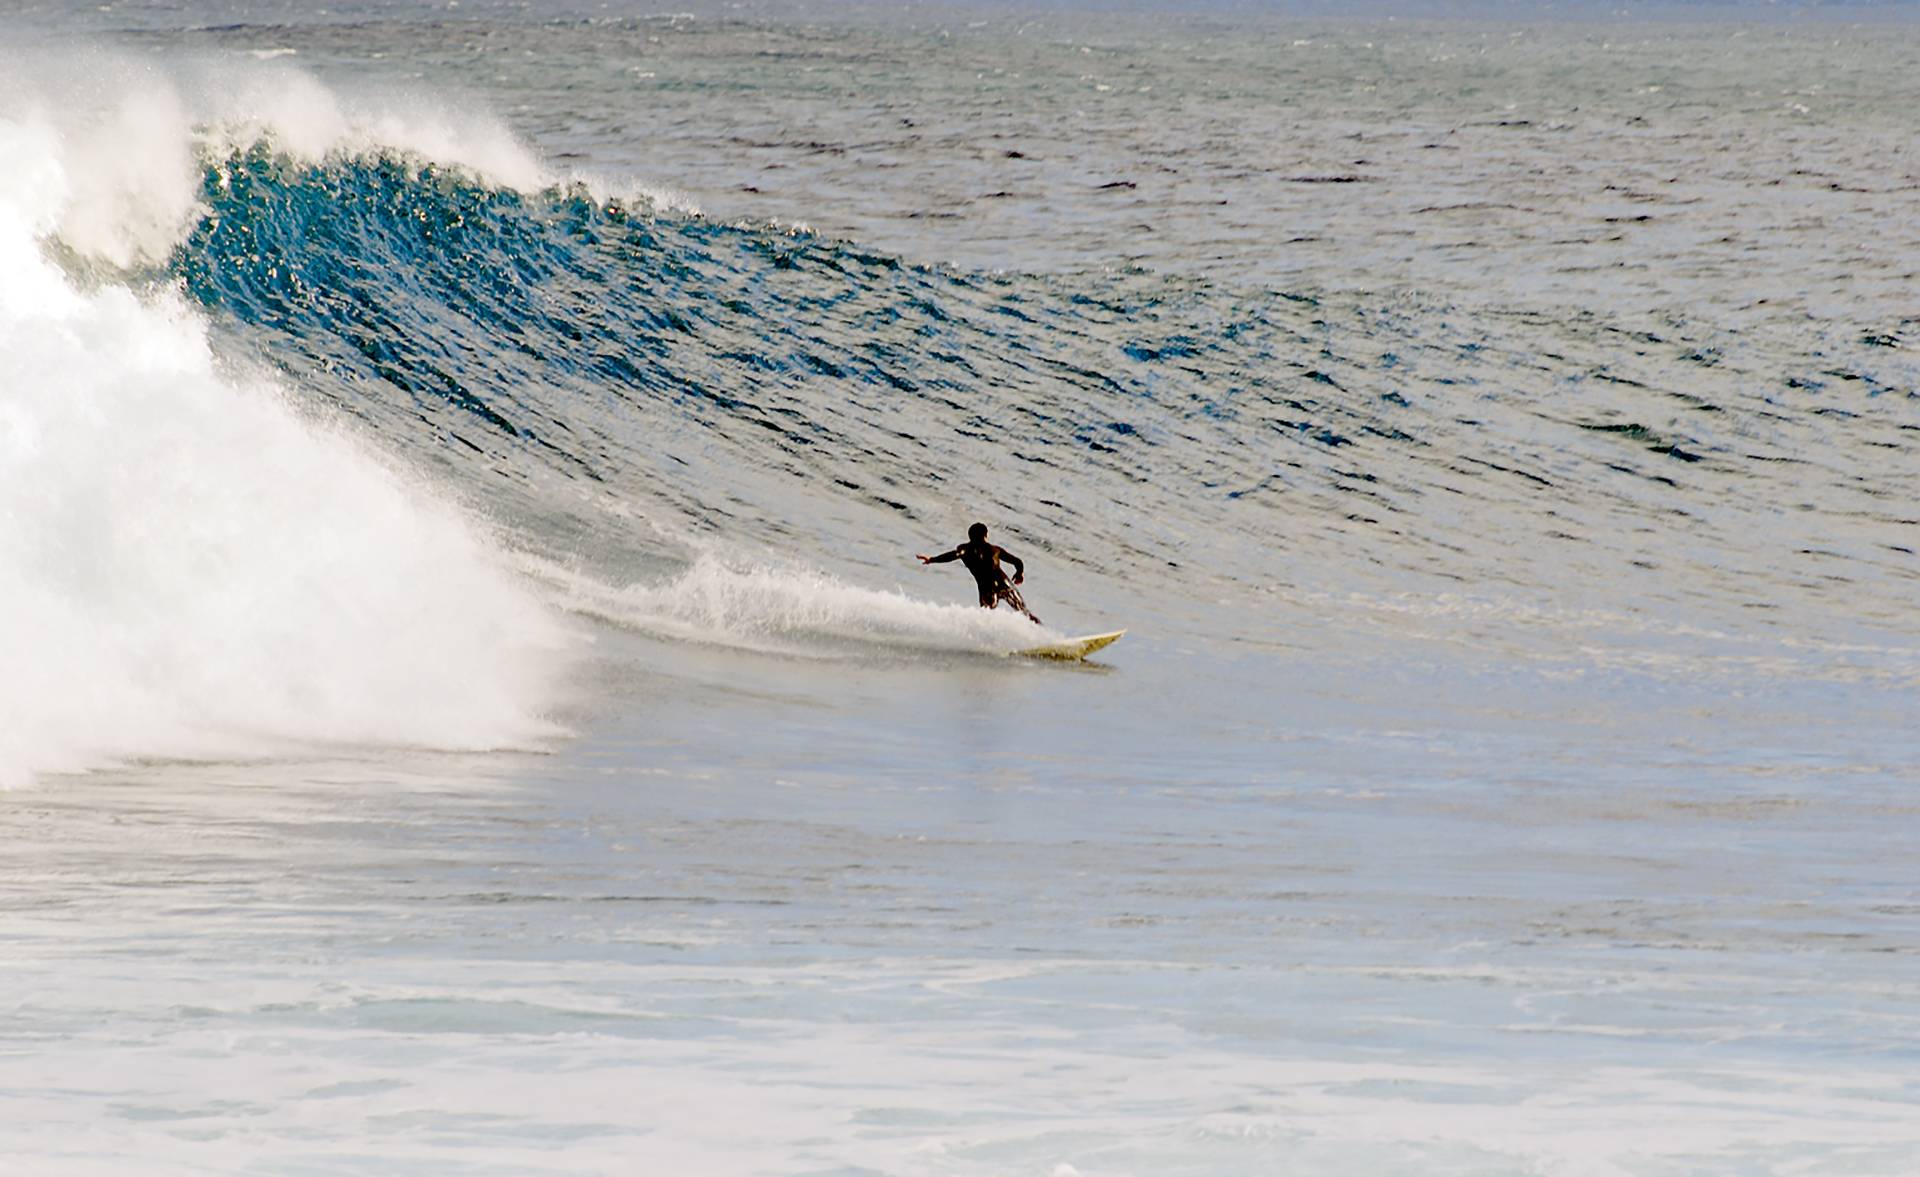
[171,144,1920,676]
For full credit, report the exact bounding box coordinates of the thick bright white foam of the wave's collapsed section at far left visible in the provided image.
[0,98,564,783]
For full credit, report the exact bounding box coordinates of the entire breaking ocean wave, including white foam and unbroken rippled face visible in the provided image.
[0,45,1920,780]
